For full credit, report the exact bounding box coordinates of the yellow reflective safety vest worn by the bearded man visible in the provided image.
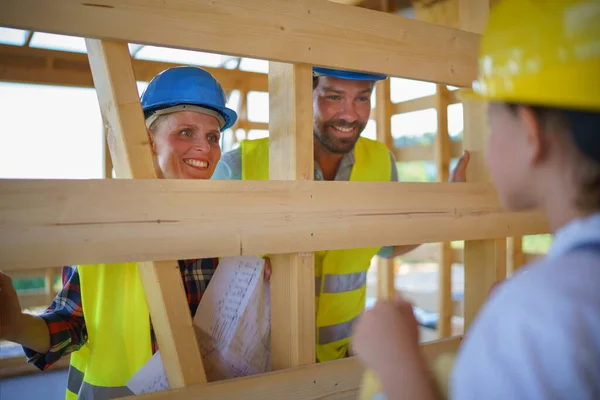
[241,137,391,362]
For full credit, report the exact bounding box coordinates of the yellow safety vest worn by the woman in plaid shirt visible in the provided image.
[66,263,152,400]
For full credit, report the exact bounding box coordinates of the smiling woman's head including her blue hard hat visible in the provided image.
[141,67,237,179]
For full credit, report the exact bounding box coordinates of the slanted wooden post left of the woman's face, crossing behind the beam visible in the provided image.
[86,39,206,389]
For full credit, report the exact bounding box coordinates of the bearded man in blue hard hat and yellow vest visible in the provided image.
[212,67,465,362]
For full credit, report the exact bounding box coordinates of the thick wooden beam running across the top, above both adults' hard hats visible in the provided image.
[0,0,479,86]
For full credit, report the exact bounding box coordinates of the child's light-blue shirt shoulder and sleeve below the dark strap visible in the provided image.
[452,260,600,398]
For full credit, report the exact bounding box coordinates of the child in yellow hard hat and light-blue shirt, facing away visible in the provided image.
[352,0,600,400]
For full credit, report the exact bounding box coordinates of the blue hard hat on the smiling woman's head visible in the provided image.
[141,66,238,131]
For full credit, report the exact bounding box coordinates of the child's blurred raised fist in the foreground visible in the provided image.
[351,296,420,373]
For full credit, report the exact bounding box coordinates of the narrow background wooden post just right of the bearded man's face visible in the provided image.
[375,79,395,298]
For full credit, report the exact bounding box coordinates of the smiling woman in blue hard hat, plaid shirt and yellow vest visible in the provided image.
[0,67,271,400]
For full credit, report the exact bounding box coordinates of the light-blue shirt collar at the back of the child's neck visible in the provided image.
[547,212,600,258]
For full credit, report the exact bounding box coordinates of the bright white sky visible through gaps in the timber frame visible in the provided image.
[0,28,463,179]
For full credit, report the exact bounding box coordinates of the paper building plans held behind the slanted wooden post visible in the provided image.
[127,257,271,394]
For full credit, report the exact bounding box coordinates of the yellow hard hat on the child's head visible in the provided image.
[465,0,600,110]
